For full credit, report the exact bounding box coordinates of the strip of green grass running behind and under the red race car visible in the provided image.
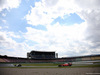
[14,63,100,69]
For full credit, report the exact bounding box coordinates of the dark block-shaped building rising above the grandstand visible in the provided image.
[27,50,58,59]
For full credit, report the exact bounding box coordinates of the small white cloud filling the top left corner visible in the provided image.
[0,0,21,12]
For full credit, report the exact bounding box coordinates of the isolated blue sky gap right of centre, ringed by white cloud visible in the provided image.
[53,13,84,25]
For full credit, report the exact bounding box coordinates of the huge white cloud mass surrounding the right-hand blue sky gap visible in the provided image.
[25,0,100,56]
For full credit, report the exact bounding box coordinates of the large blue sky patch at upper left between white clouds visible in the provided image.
[1,0,35,32]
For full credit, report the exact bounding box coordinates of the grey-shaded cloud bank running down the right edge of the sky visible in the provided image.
[77,0,100,53]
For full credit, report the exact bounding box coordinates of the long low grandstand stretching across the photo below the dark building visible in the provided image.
[0,55,100,63]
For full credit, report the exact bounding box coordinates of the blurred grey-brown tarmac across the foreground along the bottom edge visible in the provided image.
[0,67,100,75]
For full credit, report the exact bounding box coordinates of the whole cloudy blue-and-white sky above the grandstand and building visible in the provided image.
[0,0,100,57]
